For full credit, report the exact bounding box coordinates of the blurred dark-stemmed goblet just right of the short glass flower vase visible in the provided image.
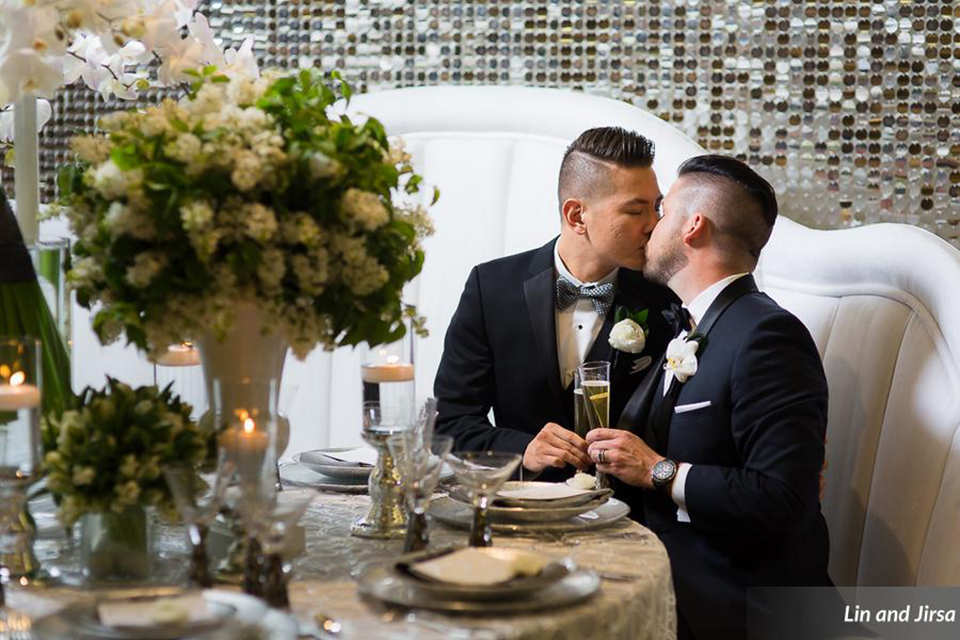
[163,455,236,589]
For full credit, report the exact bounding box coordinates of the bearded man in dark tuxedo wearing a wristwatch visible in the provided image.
[587,156,831,640]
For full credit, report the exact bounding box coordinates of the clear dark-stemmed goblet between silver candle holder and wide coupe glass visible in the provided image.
[387,430,453,553]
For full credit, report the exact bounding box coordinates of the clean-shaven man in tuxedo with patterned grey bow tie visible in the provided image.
[434,127,675,478]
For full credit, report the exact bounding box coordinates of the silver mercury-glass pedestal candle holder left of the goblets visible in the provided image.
[351,401,414,539]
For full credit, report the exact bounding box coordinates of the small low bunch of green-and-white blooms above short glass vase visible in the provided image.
[44,379,212,525]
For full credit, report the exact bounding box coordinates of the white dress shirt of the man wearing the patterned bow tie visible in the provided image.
[553,241,617,389]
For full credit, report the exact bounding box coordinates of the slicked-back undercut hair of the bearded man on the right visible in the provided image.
[677,155,778,263]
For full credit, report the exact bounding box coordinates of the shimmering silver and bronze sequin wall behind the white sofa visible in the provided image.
[7,0,960,245]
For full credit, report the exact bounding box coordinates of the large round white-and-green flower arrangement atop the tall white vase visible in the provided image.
[59,72,436,358]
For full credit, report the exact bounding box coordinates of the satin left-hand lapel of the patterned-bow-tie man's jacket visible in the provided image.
[523,242,563,402]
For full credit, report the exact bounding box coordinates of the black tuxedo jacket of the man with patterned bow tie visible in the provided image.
[434,239,676,479]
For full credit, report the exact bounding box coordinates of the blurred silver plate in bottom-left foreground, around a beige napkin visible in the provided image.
[33,587,298,640]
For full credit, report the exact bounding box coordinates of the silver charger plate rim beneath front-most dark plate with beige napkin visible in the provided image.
[357,564,600,614]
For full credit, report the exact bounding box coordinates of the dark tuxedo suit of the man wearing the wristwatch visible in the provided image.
[621,276,831,640]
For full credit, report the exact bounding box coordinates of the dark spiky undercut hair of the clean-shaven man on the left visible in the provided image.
[557,127,654,208]
